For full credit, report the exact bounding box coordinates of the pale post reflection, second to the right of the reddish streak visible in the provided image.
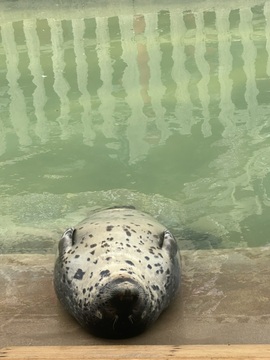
[170,12,193,135]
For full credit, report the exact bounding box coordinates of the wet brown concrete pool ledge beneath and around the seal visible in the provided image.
[0,248,270,347]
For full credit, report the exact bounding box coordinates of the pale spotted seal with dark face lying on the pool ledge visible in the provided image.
[54,206,180,338]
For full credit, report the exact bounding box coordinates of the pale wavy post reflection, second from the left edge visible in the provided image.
[23,19,50,143]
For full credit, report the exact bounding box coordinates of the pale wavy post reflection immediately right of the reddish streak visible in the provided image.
[144,13,171,144]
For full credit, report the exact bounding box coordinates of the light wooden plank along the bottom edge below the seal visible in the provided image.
[0,345,270,360]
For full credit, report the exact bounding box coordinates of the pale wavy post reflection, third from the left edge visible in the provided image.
[48,19,71,139]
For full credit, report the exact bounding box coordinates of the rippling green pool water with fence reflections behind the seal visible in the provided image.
[0,1,270,252]
